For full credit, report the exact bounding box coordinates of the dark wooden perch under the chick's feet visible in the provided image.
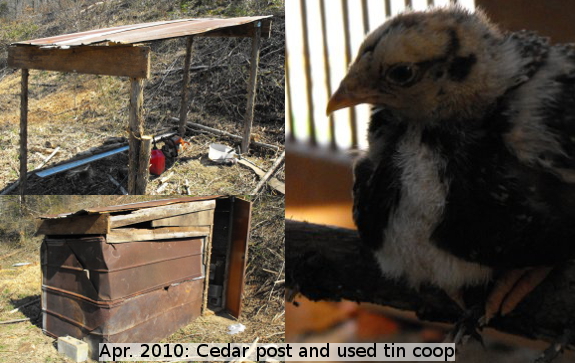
[285,220,575,348]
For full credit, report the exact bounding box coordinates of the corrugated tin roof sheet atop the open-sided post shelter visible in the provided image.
[15,15,271,47]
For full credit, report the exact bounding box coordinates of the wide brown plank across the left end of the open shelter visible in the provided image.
[8,45,150,78]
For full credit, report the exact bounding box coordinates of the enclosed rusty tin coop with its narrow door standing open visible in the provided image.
[38,197,251,354]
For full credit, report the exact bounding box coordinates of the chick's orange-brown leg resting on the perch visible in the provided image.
[482,267,552,324]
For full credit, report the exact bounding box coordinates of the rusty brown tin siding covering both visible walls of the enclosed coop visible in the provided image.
[41,236,205,353]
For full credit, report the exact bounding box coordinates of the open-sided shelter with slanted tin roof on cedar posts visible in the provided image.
[8,16,272,195]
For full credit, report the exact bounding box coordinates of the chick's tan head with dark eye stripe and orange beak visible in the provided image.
[327,7,514,121]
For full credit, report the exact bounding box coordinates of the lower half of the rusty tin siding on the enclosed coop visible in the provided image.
[42,279,203,352]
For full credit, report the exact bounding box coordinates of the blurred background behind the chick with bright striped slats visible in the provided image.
[285,0,575,362]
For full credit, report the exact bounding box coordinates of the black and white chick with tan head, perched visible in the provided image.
[327,6,575,340]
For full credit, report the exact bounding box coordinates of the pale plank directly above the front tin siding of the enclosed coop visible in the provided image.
[106,227,210,243]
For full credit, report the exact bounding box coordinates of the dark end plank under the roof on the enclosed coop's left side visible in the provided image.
[36,214,110,235]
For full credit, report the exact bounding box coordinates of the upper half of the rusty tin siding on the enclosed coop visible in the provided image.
[42,237,204,300]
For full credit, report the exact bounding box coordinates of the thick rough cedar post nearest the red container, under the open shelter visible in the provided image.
[128,78,147,194]
